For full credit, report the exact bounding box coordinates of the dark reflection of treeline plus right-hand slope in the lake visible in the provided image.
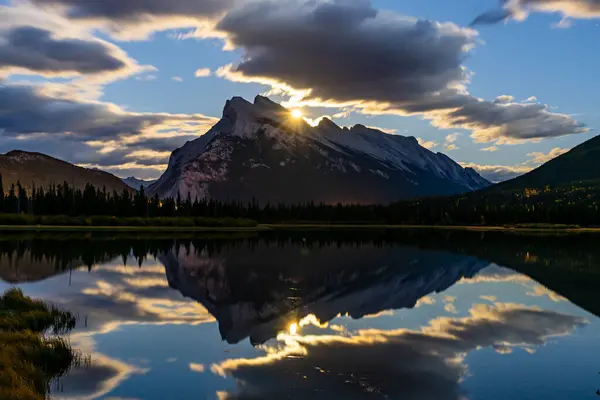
[0,229,600,315]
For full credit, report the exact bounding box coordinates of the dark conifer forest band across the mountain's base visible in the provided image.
[0,176,600,226]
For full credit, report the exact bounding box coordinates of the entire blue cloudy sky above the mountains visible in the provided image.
[0,0,600,181]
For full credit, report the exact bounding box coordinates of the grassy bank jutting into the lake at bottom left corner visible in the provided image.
[0,289,79,400]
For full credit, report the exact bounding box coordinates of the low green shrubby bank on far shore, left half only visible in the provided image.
[0,214,258,228]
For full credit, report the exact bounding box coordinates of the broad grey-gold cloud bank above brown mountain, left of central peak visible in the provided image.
[0,84,217,177]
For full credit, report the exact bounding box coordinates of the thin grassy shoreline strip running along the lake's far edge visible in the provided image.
[0,224,600,233]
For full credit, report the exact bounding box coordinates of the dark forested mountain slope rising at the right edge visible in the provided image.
[490,136,600,190]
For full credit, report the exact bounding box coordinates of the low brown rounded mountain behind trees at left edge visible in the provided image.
[0,150,129,192]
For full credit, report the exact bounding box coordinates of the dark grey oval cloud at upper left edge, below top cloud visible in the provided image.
[0,26,135,78]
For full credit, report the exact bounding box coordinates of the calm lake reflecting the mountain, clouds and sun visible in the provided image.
[0,230,600,400]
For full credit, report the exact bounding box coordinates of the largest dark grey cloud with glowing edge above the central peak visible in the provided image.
[216,0,586,142]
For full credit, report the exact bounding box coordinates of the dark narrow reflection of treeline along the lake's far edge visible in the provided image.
[0,229,600,272]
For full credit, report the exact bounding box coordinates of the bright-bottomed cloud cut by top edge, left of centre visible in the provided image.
[31,0,235,40]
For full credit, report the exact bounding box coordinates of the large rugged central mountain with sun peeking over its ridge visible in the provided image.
[149,96,490,204]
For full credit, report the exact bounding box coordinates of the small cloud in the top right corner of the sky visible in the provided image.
[472,0,600,28]
